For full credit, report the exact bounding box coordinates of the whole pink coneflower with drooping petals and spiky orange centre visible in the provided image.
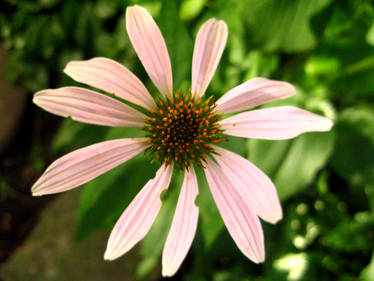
[32,6,332,276]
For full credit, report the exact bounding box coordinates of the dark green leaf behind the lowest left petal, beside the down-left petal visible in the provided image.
[77,128,158,239]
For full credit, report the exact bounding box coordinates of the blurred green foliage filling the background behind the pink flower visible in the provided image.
[0,0,374,281]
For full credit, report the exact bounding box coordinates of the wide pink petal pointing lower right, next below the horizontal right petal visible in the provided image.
[214,146,282,223]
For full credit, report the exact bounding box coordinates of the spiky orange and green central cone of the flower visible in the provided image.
[144,89,225,169]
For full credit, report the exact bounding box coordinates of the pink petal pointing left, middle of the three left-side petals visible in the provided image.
[33,87,146,127]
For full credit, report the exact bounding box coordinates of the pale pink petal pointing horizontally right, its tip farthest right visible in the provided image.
[219,106,333,140]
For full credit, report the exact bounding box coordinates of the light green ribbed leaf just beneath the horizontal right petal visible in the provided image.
[249,132,334,200]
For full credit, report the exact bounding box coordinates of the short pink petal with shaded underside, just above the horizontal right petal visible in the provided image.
[216,77,296,114]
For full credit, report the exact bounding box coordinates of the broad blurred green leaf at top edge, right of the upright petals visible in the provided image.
[245,0,331,52]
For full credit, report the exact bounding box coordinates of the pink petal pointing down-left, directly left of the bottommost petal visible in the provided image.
[104,164,173,260]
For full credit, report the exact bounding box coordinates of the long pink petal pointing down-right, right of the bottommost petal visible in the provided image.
[205,159,265,263]
